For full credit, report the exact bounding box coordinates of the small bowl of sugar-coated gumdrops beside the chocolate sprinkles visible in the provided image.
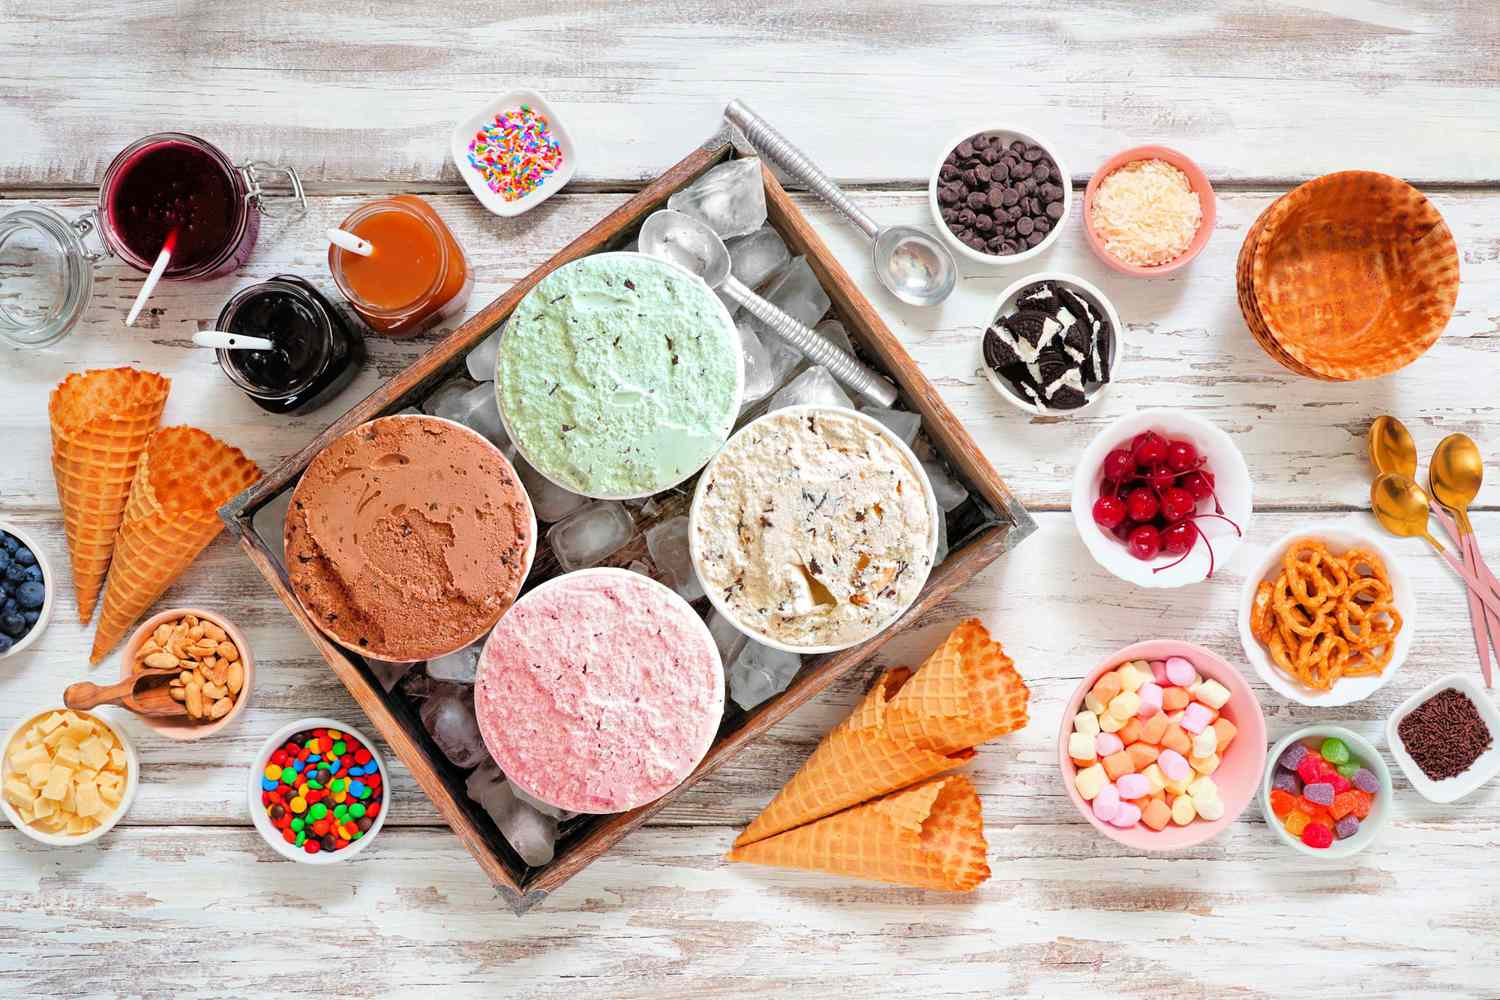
[1260,726,1392,859]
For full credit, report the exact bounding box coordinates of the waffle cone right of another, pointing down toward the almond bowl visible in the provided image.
[90,427,261,663]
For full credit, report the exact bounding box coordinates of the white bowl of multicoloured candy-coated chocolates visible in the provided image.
[249,718,390,865]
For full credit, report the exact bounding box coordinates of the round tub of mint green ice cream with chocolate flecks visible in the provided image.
[495,253,744,499]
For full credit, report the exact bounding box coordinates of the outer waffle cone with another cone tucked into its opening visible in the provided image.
[735,667,974,847]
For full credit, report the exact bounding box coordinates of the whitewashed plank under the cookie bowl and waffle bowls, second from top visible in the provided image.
[0,192,1500,510]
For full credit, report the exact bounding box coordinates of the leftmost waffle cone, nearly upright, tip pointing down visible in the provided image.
[47,367,171,624]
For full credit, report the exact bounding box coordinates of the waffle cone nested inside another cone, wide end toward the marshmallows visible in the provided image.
[885,618,1031,754]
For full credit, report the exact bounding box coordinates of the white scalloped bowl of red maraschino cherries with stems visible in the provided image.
[1073,409,1253,588]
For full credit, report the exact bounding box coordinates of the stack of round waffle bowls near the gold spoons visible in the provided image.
[1235,171,1458,382]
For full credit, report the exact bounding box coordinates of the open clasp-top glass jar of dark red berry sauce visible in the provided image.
[99,132,308,279]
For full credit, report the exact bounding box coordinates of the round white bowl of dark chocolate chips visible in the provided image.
[927,127,1073,267]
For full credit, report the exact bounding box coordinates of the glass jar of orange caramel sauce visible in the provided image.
[329,195,474,337]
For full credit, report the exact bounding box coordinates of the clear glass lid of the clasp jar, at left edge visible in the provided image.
[0,208,99,348]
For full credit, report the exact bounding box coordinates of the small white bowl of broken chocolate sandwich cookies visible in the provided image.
[980,271,1121,417]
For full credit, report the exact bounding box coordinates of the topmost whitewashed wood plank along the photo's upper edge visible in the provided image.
[0,0,1500,187]
